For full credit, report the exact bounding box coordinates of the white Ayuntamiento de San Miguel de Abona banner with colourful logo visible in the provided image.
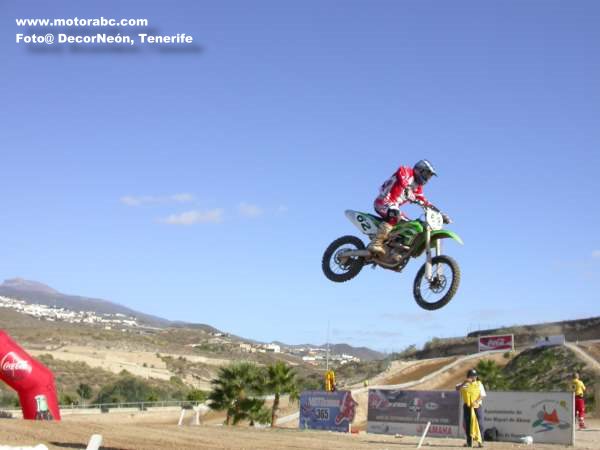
[482,392,575,445]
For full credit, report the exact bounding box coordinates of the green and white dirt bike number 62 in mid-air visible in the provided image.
[322,203,463,311]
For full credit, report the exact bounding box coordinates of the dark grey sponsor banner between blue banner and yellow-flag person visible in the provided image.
[367,389,459,437]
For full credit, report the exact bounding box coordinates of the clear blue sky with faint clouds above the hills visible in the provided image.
[0,0,600,351]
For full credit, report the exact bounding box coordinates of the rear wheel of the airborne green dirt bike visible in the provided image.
[321,236,365,283]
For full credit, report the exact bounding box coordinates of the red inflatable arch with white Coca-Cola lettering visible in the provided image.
[0,330,60,420]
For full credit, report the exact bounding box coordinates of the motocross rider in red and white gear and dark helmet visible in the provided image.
[368,159,451,256]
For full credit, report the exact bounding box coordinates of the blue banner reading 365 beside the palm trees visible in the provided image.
[300,391,358,432]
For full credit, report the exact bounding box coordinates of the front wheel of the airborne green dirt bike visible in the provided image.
[413,255,460,311]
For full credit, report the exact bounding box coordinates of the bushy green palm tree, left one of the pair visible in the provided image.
[208,363,265,425]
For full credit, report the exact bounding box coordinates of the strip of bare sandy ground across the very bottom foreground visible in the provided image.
[0,411,600,450]
